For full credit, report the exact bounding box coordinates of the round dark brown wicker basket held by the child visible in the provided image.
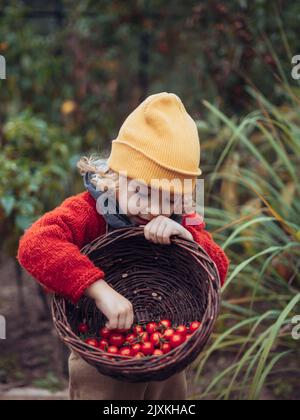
[52,227,220,382]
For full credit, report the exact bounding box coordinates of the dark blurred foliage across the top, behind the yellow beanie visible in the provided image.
[0,0,299,129]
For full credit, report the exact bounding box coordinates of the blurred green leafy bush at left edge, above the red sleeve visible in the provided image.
[0,110,80,253]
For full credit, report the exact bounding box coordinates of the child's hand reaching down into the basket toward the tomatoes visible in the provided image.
[85,280,134,329]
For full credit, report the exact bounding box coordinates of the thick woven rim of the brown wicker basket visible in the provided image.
[52,227,221,375]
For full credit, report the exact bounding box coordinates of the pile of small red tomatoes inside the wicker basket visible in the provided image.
[78,319,201,358]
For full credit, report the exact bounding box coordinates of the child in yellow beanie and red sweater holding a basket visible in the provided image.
[17,92,229,400]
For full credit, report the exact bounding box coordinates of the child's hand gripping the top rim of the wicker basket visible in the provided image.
[144,216,193,245]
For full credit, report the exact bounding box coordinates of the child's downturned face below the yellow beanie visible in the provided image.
[117,179,182,225]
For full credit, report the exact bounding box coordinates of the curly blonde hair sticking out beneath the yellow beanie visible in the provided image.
[77,154,196,213]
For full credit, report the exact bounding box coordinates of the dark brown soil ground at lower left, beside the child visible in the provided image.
[0,254,67,394]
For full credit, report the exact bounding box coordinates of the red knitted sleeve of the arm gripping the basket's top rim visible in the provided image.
[182,213,230,286]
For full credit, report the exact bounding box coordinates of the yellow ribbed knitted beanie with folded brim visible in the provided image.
[107,92,202,192]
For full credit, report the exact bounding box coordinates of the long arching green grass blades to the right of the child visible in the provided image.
[195,86,300,400]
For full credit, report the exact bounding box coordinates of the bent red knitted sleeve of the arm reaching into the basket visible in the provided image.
[17,192,105,303]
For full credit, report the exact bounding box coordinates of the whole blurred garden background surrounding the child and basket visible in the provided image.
[0,0,300,400]
